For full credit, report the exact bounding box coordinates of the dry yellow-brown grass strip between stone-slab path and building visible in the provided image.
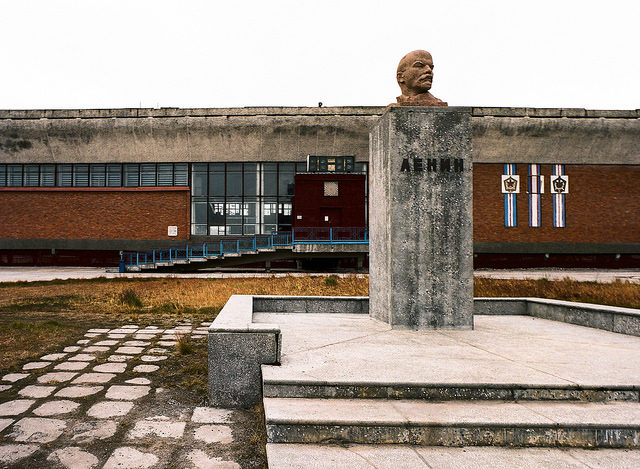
[0,276,640,371]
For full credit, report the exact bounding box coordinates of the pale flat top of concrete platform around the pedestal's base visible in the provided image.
[253,313,640,392]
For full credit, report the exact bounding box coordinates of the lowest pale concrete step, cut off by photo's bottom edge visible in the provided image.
[267,443,640,469]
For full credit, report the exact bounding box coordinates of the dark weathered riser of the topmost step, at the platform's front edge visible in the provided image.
[263,378,640,402]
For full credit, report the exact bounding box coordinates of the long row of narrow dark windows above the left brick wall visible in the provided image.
[0,163,189,187]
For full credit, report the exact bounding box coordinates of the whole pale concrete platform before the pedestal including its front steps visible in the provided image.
[253,313,640,469]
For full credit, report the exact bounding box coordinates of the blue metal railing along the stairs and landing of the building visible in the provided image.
[120,228,369,272]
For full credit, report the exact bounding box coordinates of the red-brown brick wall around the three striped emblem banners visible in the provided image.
[473,164,640,243]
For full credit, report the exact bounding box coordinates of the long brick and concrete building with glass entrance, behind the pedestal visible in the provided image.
[0,107,640,267]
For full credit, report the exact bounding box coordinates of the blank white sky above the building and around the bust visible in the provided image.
[0,0,640,109]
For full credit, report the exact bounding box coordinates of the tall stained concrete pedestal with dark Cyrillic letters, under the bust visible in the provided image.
[369,107,473,330]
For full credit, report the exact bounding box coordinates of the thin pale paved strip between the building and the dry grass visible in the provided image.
[0,267,640,283]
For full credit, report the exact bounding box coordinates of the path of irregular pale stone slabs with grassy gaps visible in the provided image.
[0,323,240,469]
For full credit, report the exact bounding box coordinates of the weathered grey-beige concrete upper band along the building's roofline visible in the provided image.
[0,107,640,164]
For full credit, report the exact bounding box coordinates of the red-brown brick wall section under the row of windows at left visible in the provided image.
[0,188,190,239]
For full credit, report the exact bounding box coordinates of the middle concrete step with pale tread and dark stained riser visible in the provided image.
[264,398,640,448]
